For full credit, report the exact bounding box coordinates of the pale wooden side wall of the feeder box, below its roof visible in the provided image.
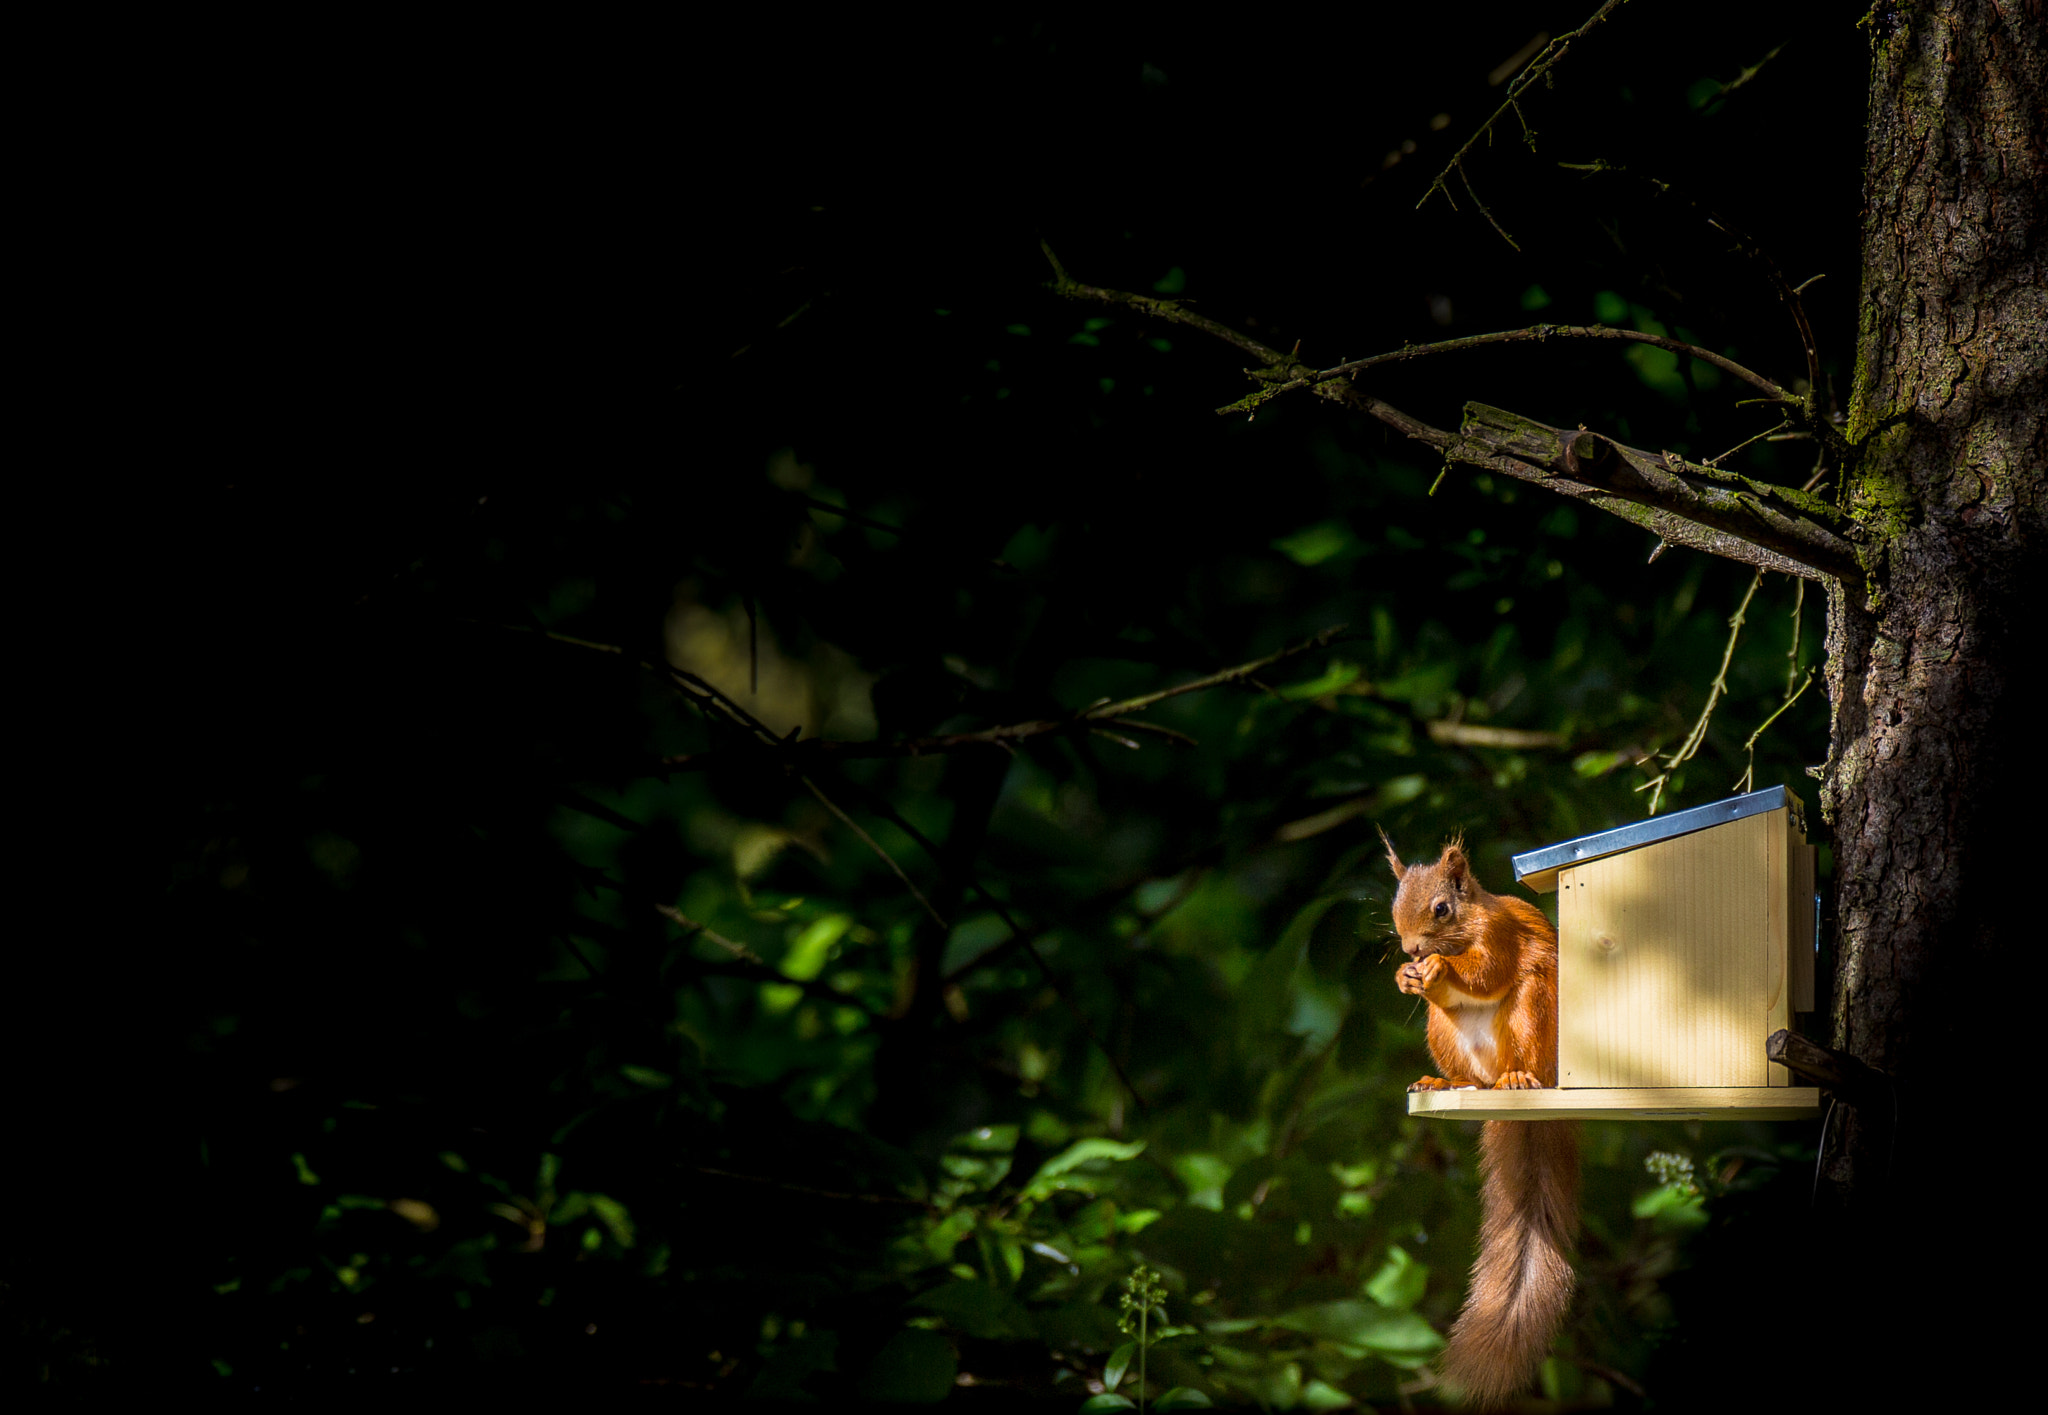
[1559,811,1786,1089]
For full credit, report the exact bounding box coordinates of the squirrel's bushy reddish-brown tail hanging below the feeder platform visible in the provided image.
[1444,1120,1579,1405]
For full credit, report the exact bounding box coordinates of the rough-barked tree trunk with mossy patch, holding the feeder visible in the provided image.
[1821,0,2048,1220]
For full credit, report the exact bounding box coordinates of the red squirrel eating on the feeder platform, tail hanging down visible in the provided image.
[1380,831,1579,1405]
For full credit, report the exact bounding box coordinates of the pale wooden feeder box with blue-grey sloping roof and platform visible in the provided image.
[1409,786,1821,1120]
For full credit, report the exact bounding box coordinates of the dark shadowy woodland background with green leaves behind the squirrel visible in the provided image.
[16,4,1866,1409]
